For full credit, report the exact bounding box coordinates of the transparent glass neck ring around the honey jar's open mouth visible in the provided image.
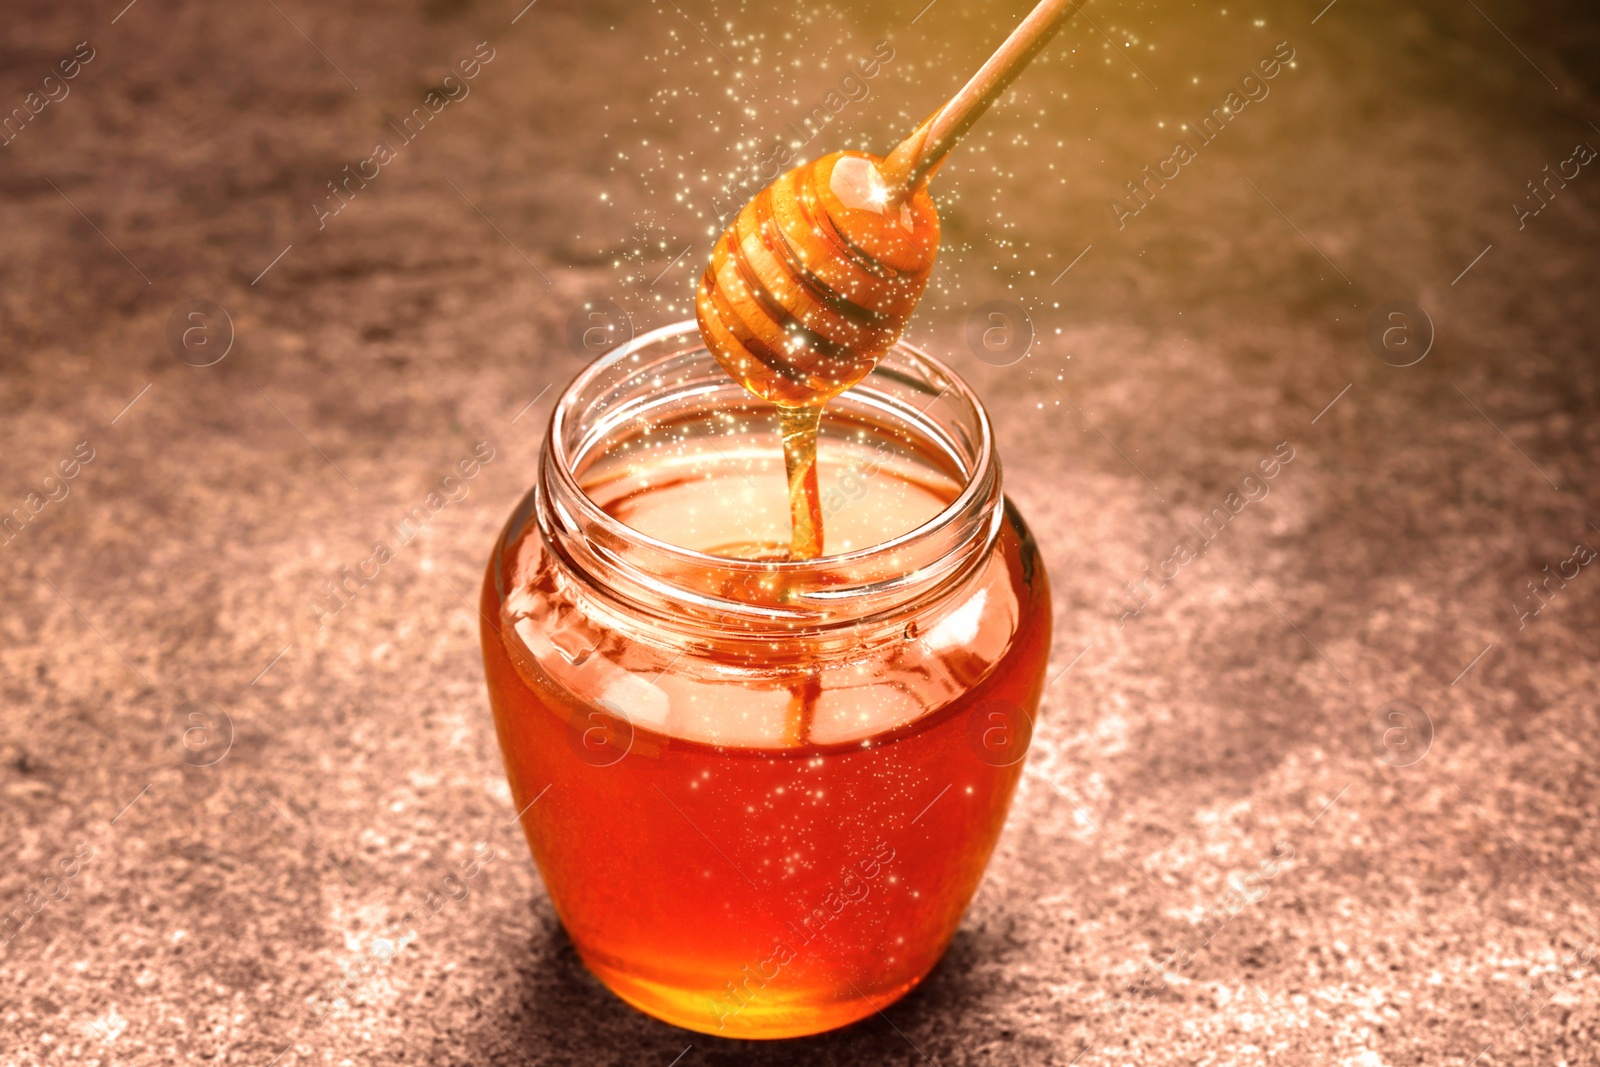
[539,320,1000,630]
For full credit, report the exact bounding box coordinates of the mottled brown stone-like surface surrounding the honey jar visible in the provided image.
[0,0,1600,1067]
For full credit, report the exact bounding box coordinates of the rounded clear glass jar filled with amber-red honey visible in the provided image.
[482,322,1050,1038]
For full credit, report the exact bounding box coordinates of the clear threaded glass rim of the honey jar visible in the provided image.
[538,318,1002,625]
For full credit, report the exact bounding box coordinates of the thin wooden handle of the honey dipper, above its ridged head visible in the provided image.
[878,0,1085,203]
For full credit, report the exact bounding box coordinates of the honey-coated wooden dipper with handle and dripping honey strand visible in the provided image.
[694,0,1083,560]
